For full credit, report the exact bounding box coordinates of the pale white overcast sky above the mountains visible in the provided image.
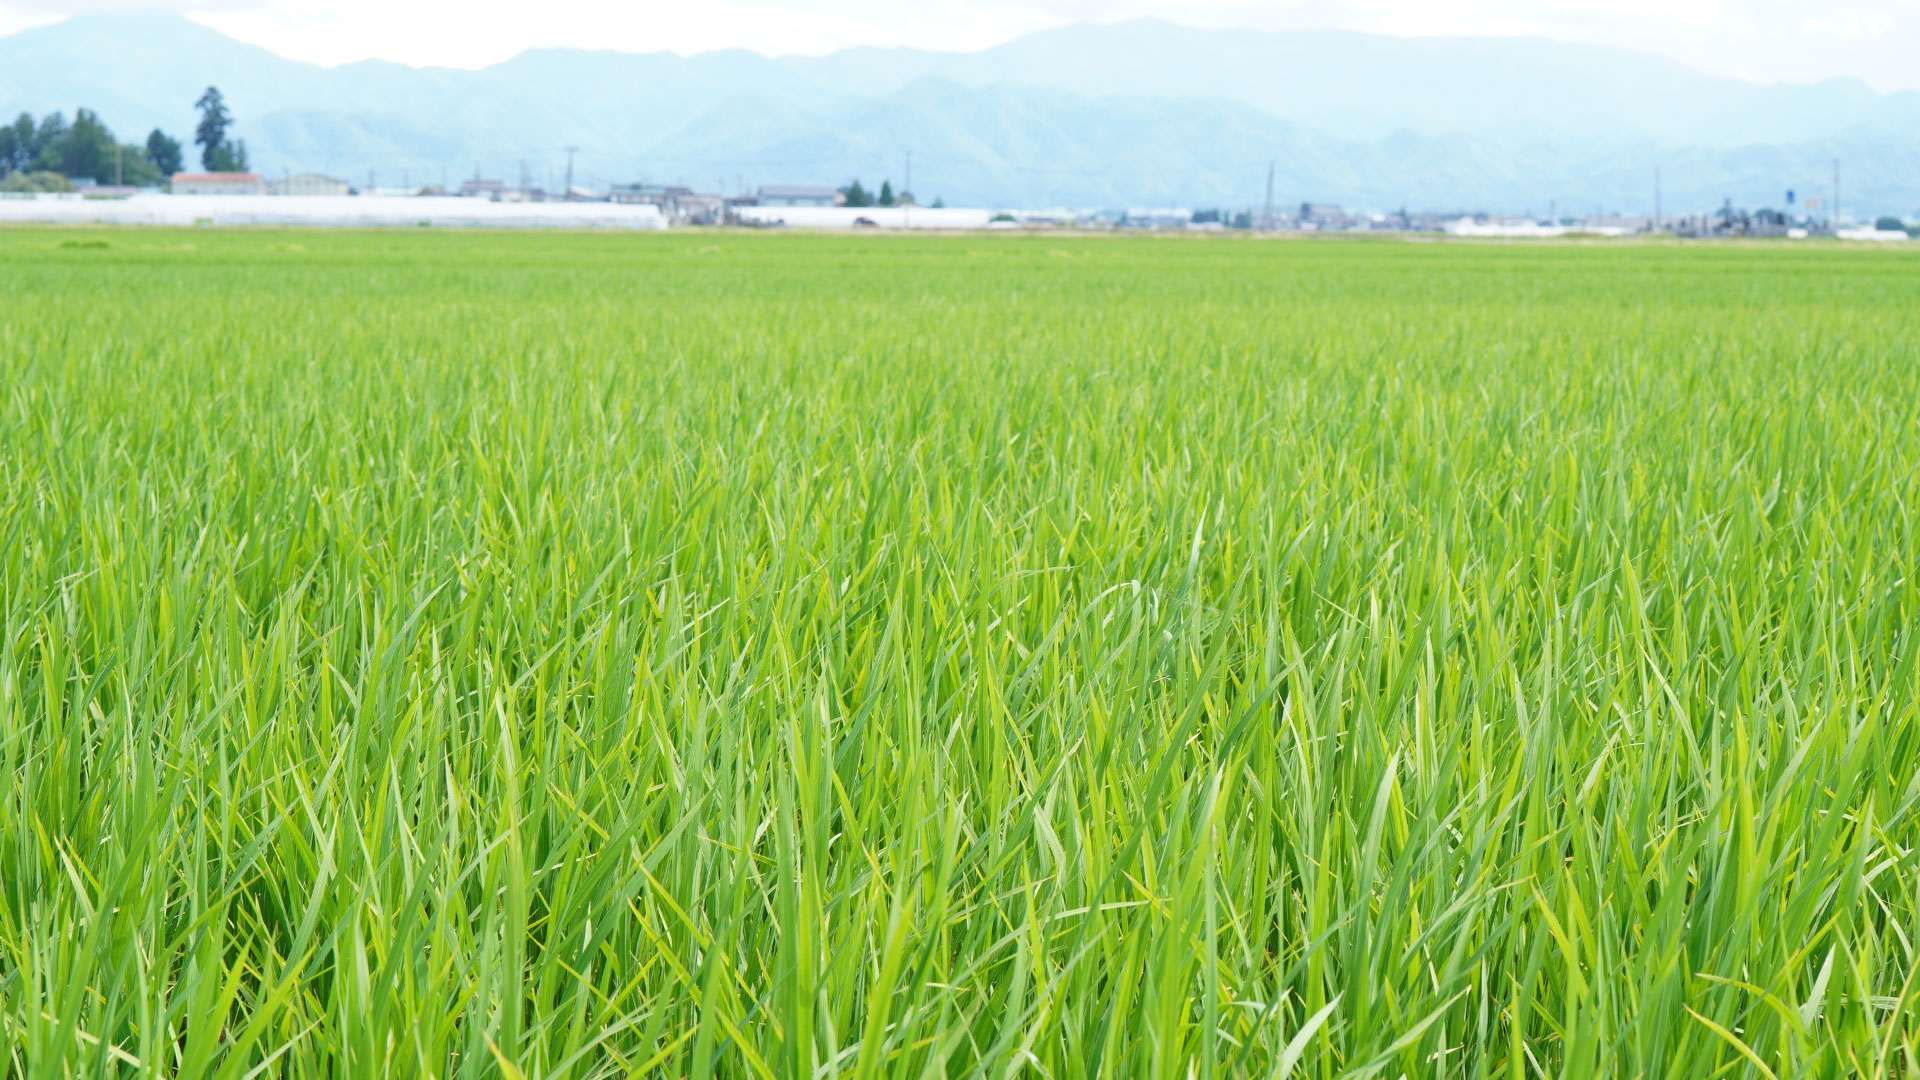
[11,0,1920,90]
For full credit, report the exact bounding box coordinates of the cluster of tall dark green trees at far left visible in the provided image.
[0,86,248,190]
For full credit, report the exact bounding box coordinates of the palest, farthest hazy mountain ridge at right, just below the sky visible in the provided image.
[810,19,1920,146]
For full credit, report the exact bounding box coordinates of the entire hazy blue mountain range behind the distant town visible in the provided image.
[0,15,1920,215]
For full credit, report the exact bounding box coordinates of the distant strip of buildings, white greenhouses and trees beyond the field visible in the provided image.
[0,86,1920,242]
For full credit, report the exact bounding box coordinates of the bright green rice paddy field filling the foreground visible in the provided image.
[0,231,1920,1080]
